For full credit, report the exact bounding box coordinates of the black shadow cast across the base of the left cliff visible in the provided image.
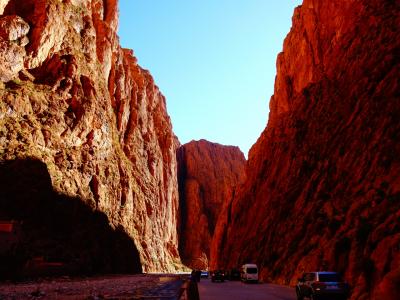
[0,159,142,279]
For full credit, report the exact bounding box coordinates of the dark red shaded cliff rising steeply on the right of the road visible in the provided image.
[211,0,400,299]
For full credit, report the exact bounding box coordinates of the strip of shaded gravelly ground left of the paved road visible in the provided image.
[0,274,188,300]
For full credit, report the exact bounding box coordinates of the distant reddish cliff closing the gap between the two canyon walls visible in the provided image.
[177,140,246,269]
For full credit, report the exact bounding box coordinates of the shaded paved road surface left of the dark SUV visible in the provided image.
[198,279,296,300]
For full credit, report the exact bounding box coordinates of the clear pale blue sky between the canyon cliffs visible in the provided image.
[119,0,301,156]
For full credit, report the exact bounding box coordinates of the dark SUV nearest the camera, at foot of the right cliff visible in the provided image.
[296,272,349,300]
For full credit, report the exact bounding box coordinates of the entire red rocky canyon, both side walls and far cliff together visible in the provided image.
[0,0,400,299]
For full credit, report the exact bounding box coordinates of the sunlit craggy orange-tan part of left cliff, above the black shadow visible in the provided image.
[0,0,179,271]
